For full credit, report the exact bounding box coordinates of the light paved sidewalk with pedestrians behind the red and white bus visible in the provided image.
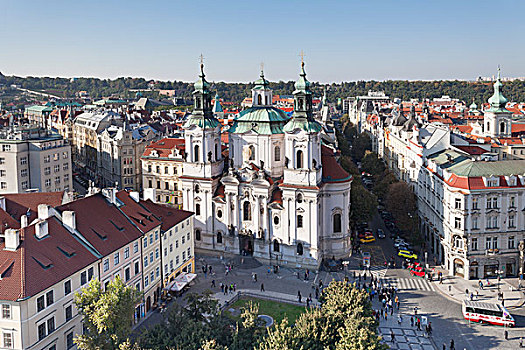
[432,269,525,309]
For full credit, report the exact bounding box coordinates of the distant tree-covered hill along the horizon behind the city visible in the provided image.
[0,74,525,105]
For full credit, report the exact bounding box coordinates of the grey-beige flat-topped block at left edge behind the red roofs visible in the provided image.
[0,125,73,193]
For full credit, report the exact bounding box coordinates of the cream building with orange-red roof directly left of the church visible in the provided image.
[141,138,185,208]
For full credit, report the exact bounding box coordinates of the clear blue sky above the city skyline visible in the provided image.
[0,0,525,82]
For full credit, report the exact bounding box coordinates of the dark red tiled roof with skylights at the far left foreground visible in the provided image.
[0,217,98,301]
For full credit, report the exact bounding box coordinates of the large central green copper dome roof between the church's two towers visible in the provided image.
[228,107,288,135]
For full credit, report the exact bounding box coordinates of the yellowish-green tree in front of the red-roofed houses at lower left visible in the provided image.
[75,277,141,350]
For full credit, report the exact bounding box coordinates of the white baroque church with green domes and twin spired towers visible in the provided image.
[180,62,352,268]
